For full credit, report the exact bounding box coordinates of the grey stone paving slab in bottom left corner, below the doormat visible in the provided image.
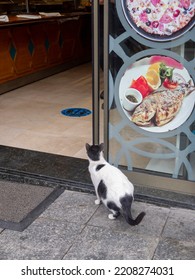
[0,218,83,260]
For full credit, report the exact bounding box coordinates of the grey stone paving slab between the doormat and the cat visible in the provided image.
[41,191,98,224]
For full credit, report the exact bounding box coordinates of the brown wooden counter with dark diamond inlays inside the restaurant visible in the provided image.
[0,13,91,93]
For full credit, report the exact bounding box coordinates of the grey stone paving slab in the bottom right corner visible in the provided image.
[153,238,195,260]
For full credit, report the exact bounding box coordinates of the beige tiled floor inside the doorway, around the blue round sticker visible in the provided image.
[0,63,103,158]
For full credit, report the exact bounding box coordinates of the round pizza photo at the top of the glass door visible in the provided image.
[122,0,195,41]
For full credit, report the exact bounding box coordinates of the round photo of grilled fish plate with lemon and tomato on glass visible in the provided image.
[119,56,195,132]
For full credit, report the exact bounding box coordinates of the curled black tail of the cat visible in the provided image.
[120,195,146,226]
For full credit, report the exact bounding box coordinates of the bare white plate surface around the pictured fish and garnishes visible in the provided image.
[119,58,195,132]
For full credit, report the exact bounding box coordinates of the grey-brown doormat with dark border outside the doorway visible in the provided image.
[0,181,64,231]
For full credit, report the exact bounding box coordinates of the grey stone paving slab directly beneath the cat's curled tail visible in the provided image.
[88,202,170,236]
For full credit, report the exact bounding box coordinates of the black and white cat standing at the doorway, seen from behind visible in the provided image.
[86,144,145,226]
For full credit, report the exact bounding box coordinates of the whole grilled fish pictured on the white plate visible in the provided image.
[131,81,195,127]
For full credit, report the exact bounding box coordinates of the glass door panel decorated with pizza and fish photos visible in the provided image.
[104,0,195,195]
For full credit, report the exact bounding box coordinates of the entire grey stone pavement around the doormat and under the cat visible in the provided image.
[0,190,195,260]
